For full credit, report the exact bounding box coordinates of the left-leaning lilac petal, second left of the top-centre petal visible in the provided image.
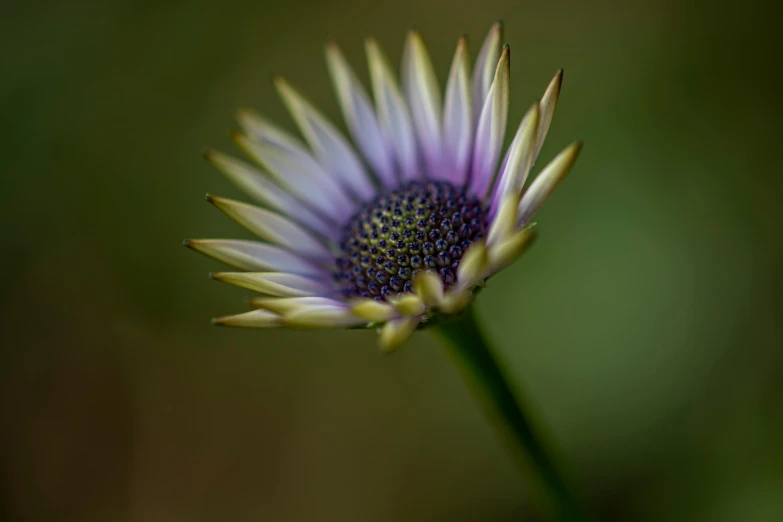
[326,44,397,187]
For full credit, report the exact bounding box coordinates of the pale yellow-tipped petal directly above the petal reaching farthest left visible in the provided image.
[207,196,334,261]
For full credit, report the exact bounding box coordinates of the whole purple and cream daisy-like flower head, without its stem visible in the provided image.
[185,23,581,350]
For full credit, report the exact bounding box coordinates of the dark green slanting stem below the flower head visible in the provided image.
[435,306,586,521]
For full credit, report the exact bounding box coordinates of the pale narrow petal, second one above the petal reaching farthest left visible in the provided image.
[204,150,334,237]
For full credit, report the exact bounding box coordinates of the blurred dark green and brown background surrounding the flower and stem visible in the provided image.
[0,0,783,522]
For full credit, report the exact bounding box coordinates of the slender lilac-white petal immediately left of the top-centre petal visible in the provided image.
[366,39,420,179]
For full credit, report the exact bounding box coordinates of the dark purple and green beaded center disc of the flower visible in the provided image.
[334,181,486,301]
